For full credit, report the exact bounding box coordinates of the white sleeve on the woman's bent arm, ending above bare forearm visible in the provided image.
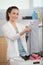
[2,27,20,40]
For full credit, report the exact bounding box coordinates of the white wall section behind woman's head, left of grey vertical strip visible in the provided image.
[0,0,29,9]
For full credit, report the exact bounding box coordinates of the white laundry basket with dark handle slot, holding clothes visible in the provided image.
[10,59,42,65]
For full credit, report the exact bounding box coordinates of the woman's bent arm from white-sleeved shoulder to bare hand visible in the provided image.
[2,27,30,40]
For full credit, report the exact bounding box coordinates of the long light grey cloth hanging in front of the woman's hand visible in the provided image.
[27,20,39,54]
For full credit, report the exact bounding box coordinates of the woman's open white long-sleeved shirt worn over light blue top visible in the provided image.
[2,21,28,59]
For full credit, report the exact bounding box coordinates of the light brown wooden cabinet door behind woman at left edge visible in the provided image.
[0,36,7,62]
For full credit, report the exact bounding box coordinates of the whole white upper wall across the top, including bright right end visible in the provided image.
[0,0,43,9]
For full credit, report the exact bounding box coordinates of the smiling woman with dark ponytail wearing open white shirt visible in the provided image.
[2,6,30,64]
